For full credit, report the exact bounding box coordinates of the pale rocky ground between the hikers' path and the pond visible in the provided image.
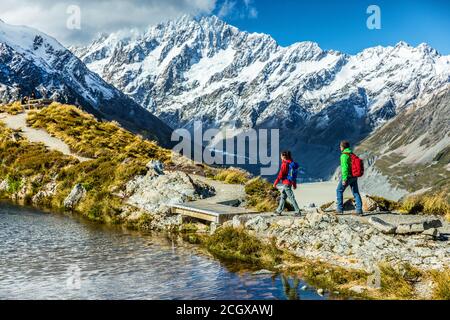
[230,210,450,272]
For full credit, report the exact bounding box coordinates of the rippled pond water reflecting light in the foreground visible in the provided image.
[0,203,323,299]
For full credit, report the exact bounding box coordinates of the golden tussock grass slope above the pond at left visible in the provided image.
[0,103,171,222]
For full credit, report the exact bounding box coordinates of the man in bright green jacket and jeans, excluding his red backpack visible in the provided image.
[336,140,363,215]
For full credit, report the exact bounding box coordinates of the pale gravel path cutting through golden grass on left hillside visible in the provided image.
[0,112,92,162]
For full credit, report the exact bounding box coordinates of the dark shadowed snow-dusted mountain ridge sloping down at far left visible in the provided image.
[0,20,171,143]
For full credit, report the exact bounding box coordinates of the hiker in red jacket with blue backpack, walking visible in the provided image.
[273,151,300,216]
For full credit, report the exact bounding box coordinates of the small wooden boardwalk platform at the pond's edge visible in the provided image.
[172,200,257,224]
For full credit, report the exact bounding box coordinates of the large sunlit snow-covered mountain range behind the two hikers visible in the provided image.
[73,16,450,178]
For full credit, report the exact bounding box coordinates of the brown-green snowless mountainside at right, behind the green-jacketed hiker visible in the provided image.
[357,87,450,196]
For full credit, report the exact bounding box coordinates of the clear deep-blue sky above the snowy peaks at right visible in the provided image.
[214,0,450,55]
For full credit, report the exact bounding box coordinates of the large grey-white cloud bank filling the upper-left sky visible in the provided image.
[0,0,216,44]
